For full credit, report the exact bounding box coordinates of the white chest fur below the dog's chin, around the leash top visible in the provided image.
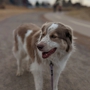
[42,53,68,75]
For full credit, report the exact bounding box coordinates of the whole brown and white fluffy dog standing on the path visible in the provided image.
[13,22,74,90]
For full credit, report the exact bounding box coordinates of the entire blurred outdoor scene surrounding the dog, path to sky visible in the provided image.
[0,0,90,90]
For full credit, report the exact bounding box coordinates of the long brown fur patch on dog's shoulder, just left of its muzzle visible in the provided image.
[27,31,41,63]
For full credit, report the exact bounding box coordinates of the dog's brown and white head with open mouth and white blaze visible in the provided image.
[37,23,72,59]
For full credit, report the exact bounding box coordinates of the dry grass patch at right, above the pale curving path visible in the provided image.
[67,8,90,21]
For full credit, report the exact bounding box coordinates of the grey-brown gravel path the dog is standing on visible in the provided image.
[0,12,90,90]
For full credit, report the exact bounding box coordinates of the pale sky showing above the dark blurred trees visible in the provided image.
[29,0,90,6]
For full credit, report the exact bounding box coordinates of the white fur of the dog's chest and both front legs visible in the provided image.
[34,49,71,90]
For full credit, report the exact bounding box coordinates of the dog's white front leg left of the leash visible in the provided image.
[31,62,43,90]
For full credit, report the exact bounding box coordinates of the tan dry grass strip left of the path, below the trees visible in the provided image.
[0,5,51,20]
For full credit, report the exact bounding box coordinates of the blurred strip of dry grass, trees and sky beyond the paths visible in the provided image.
[0,0,90,20]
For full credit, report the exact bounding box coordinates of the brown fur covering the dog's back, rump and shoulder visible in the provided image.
[14,24,41,63]
